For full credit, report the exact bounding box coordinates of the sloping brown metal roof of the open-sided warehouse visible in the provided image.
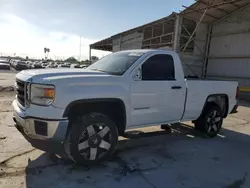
[90,0,250,51]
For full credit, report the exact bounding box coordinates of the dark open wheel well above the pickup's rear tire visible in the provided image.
[202,94,229,118]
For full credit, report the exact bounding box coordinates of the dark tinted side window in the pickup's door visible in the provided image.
[142,54,175,80]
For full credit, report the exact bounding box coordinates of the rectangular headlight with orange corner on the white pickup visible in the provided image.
[30,84,55,106]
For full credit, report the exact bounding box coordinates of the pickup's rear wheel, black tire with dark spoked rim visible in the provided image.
[194,103,223,138]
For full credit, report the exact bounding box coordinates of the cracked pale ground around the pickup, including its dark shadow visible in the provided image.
[0,73,250,188]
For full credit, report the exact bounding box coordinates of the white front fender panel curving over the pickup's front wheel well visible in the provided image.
[53,82,130,123]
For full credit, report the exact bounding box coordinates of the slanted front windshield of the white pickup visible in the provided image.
[87,52,143,75]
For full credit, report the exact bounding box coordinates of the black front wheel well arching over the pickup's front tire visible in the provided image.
[63,99,126,135]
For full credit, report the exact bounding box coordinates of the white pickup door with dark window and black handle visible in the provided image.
[131,54,186,125]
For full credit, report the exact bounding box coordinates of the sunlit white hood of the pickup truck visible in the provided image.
[16,68,112,81]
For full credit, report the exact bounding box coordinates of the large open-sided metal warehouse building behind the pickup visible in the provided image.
[90,0,250,99]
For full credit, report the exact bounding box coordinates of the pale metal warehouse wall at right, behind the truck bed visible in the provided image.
[207,8,250,86]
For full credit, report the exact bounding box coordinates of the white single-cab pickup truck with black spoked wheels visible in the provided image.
[13,50,238,165]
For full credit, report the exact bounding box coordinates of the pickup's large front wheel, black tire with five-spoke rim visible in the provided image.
[65,113,118,165]
